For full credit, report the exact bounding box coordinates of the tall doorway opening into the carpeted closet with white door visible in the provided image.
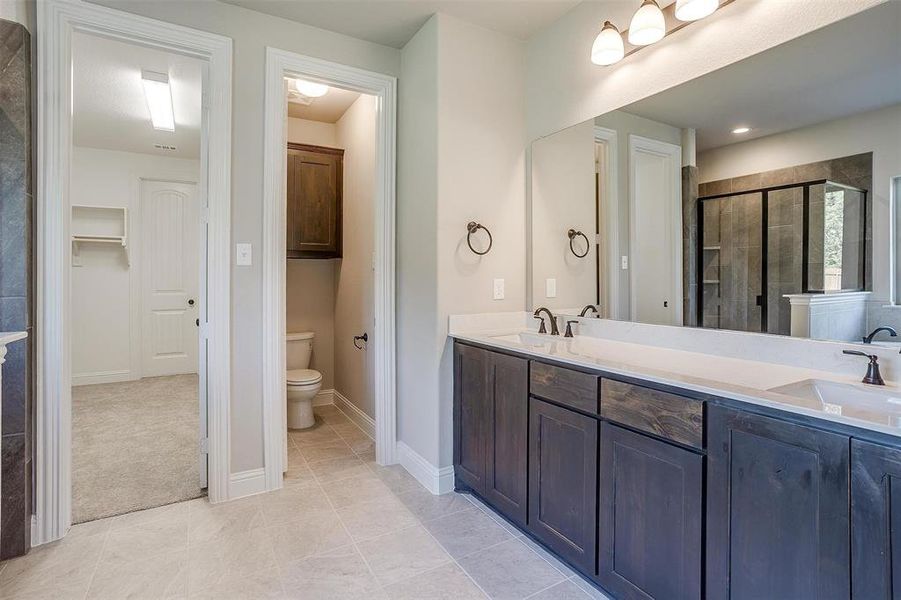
[69,32,207,523]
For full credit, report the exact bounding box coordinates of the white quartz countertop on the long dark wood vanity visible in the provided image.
[450,328,901,437]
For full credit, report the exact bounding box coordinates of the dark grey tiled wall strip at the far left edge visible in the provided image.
[0,20,34,559]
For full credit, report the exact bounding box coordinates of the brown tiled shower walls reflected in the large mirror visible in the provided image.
[683,153,873,335]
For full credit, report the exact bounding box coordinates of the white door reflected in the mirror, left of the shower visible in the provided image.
[629,135,682,325]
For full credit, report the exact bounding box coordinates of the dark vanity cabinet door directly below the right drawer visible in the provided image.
[598,423,704,600]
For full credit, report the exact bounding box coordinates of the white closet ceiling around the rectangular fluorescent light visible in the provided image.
[72,33,202,158]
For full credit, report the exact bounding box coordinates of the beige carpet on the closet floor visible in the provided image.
[72,375,201,523]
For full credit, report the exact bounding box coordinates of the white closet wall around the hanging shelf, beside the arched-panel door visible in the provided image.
[70,147,200,385]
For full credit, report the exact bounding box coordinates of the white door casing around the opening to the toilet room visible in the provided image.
[263,48,397,490]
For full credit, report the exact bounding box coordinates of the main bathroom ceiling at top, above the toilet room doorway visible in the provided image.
[221,0,584,48]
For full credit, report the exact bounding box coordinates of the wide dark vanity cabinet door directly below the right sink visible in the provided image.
[706,406,851,600]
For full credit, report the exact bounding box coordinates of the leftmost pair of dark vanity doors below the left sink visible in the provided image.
[454,344,529,526]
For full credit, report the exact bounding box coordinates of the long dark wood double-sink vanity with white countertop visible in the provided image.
[451,326,901,599]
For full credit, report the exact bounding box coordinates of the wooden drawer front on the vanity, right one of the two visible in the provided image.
[601,379,704,448]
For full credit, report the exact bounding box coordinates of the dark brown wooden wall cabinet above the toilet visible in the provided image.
[286,143,344,258]
